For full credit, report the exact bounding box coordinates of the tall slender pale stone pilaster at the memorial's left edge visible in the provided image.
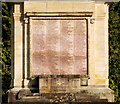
[13,3,23,89]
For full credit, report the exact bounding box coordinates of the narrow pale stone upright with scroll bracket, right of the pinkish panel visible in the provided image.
[88,16,95,86]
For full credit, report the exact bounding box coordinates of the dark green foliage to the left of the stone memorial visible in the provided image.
[2,3,11,102]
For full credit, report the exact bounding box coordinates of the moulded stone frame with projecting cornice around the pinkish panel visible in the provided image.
[26,12,93,78]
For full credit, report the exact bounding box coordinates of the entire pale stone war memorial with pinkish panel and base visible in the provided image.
[8,1,114,103]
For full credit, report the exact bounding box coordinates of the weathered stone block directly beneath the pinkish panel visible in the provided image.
[39,75,89,93]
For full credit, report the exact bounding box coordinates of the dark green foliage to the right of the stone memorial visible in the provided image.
[109,2,120,102]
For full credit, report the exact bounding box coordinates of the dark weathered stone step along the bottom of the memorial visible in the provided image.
[16,93,108,103]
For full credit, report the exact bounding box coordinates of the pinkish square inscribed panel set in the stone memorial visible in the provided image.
[30,19,87,75]
